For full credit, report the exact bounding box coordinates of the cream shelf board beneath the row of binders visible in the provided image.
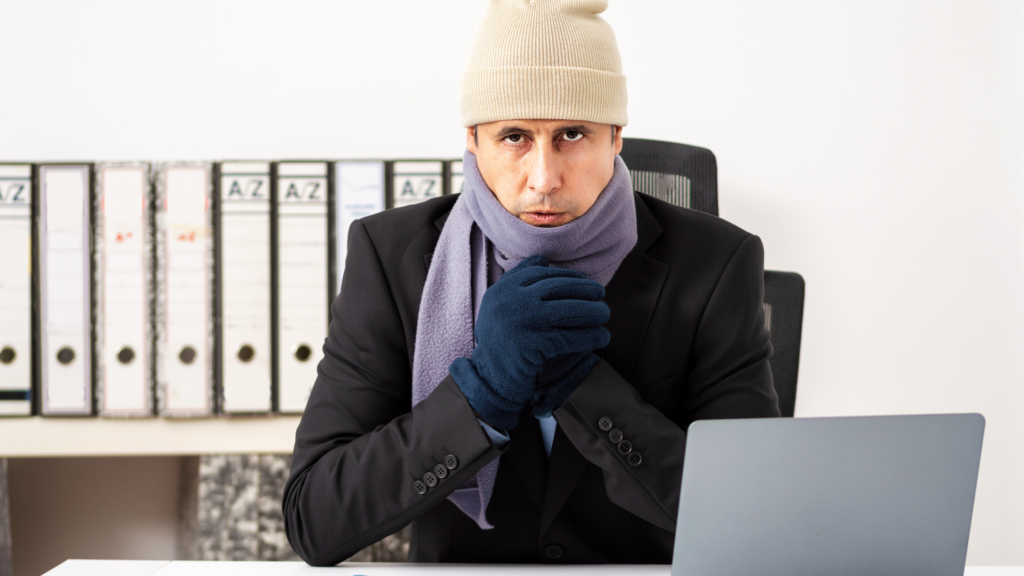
[0,416,300,458]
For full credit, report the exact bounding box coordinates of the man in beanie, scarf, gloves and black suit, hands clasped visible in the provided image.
[284,0,778,565]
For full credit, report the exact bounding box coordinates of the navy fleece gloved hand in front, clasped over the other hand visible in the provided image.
[449,255,609,430]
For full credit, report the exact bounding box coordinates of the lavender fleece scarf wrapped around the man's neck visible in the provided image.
[413,151,637,530]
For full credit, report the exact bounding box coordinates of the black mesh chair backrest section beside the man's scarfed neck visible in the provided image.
[620,138,718,216]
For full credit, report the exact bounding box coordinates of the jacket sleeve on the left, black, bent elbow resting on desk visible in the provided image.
[283,221,502,566]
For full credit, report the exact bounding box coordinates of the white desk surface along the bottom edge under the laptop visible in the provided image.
[39,560,1024,576]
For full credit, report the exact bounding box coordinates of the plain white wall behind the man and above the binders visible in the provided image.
[0,0,1024,565]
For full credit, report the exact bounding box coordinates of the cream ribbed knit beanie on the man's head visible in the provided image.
[462,0,627,127]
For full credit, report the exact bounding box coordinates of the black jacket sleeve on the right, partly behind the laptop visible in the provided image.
[554,231,779,532]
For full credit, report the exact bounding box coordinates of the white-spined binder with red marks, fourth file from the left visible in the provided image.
[154,163,214,417]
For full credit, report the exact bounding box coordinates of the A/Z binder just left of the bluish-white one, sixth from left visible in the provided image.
[274,162,330,413]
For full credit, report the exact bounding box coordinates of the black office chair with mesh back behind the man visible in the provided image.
[620,138,804,417]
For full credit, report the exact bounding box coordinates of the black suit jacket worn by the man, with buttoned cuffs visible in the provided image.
[283,194,779,565]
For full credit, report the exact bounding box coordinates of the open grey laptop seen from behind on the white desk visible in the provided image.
[672,414,985,576]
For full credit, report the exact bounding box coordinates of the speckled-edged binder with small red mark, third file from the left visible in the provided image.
[93,164,154,417]
